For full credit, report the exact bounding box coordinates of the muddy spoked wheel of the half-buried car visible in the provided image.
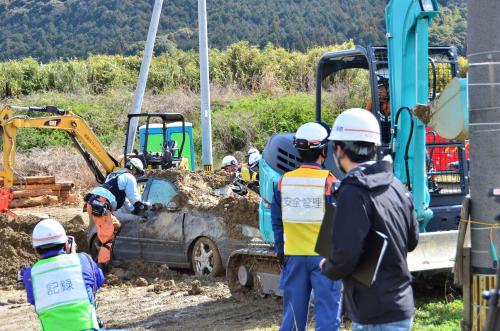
[191,237,224,277]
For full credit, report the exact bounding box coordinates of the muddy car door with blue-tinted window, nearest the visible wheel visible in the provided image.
[139,178,188,267]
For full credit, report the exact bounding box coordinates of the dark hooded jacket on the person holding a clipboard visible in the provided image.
[324,160,418,324]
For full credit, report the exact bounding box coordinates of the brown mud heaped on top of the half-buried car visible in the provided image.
[149,169,259,228]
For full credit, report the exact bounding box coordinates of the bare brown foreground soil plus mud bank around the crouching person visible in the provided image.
[0,206,281,330]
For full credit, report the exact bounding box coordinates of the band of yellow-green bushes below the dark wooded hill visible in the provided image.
[0,41,360,98]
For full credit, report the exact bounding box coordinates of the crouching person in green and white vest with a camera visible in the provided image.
[20,219,104,331]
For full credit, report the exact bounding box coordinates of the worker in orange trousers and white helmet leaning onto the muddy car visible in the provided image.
[85,158,150,265]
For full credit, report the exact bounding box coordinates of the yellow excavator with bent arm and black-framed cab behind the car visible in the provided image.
[0,106,188,216]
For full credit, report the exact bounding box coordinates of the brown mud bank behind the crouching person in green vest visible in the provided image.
[0,215,87,288]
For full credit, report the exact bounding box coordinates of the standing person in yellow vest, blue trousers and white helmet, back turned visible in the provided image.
[271,123,342,331]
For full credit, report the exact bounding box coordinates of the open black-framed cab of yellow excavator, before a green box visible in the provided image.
[124,113,192,169]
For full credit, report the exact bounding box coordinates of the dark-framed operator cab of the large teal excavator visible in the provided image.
[316,46,468,232]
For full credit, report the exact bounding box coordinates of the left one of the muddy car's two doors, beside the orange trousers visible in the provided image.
[113,180,147,260]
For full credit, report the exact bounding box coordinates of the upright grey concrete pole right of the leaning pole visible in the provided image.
[198,0,213,171]
